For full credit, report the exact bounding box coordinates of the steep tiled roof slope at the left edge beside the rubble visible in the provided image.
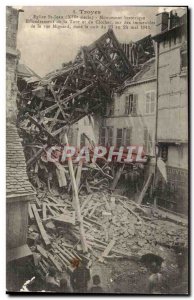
[6,124,34,197]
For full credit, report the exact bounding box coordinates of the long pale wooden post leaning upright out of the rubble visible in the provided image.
[64,133,88,252]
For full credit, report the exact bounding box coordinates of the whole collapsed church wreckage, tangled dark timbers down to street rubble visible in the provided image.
[6,5,187,292]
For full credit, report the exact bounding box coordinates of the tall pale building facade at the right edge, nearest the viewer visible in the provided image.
[153,8,188,212]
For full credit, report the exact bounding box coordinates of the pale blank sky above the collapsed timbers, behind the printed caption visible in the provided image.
[17,6,185,76]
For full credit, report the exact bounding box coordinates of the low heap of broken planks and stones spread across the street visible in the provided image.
[28,185,187,278]
